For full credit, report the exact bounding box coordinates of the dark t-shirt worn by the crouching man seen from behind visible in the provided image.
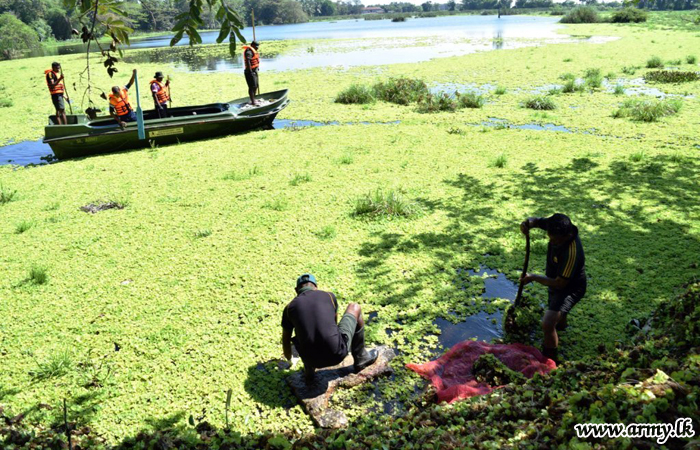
[282,289,348,367]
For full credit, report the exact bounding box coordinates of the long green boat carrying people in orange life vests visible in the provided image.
[44,89,289,159]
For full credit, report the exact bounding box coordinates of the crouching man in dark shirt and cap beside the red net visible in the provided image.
[282,273,379,383]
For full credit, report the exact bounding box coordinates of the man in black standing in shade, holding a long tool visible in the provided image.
[520,214,587,361]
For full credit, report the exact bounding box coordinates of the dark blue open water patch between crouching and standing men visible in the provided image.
[433,266,518,352]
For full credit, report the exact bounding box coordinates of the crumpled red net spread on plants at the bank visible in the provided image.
[406,341,557,403]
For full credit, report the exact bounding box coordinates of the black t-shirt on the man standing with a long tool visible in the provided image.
[535,219,586,293]
